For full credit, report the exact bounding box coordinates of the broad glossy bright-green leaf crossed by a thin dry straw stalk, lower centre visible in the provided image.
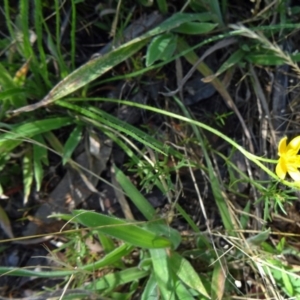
[73,210,171,248]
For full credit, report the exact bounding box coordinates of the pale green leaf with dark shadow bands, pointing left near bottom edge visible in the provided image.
[84,267,149,292]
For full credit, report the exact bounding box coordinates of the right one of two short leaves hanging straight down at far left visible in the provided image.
[33,134,49,191]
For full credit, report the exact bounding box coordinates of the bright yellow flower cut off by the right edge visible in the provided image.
[275,136,300,182]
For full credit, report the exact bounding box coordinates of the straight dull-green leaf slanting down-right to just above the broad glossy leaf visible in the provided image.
[114,166,155,220]
